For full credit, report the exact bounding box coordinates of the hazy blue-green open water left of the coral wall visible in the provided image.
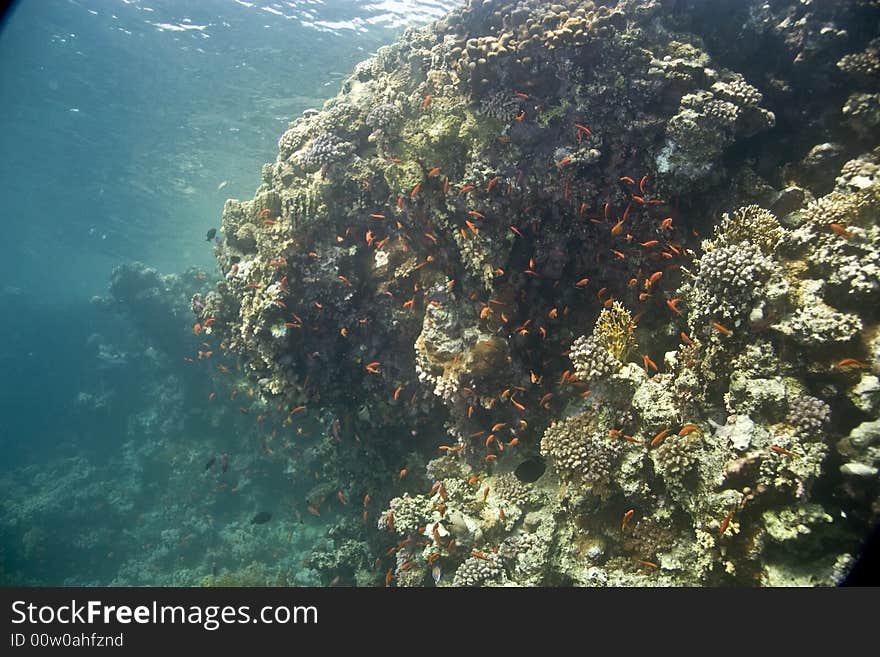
[0,0,455,584]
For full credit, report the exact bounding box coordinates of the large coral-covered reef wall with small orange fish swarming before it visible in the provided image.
[199,0,880,586]
